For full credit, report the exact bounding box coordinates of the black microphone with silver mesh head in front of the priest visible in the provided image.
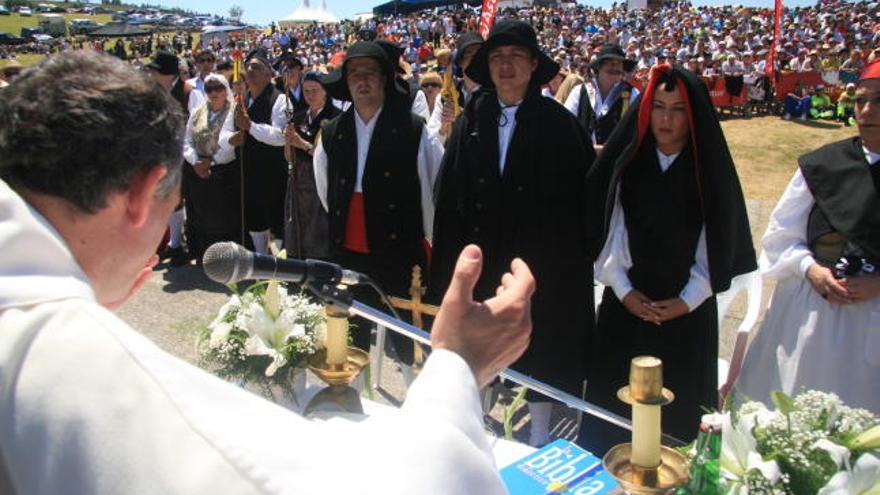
[202,242,366,285]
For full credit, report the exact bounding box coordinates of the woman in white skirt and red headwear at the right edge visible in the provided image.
[736,62,880,414]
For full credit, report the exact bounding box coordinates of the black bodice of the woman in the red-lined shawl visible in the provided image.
[620,142,703,299]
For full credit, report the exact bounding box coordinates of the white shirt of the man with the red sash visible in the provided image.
[312,109,443,241]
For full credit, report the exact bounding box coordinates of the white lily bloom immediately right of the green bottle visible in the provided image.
[721,414,781,483]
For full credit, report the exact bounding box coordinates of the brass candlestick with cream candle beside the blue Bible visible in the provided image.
[602,356,688,495]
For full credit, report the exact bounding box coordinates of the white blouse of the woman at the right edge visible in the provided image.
[758,146,880,279]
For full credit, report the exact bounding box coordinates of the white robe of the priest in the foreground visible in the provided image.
[0,181,506,495]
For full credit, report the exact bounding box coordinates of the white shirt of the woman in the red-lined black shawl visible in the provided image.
[595,150,712,311]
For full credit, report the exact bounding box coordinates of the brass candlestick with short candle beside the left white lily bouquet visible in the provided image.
[303,307,370,417]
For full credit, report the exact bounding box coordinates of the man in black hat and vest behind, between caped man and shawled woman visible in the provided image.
[565,43,639,150]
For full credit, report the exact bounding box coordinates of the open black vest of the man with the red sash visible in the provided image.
[321,104,425,266]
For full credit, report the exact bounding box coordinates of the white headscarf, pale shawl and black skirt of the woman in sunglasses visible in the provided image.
[183,74,241,260]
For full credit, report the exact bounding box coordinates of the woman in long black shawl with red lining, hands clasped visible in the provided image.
[581,65,756,452]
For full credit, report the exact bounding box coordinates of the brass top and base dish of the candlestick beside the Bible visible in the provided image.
[602,356,689,495]
